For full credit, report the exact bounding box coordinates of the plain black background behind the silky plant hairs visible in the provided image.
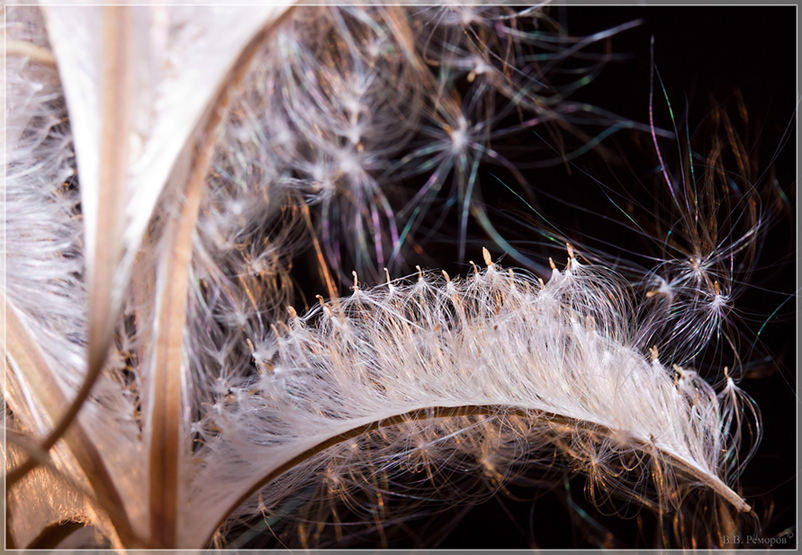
[282,6,798,549]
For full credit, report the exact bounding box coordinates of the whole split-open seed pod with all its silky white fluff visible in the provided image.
[3,2,788,550]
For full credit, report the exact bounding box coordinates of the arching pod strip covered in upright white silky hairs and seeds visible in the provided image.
[181,255,746,541]
